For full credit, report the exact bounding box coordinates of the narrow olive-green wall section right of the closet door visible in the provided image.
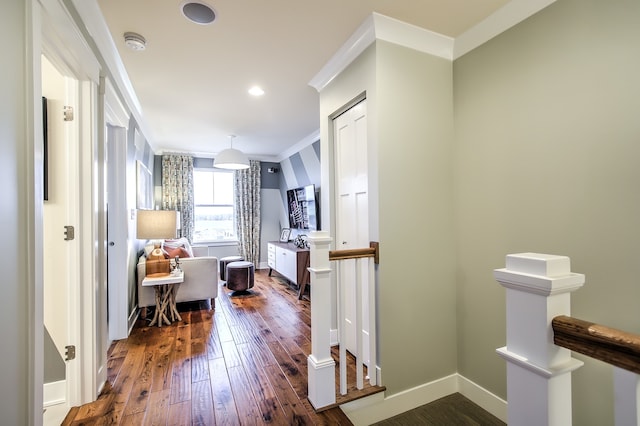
[376,41,456,395]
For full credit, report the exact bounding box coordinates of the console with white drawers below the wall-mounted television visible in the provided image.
[267,241,309,299]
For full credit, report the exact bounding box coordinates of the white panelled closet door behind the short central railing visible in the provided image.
[333,100,370,362]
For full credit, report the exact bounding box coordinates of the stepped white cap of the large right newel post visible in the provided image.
[493,253,585,296]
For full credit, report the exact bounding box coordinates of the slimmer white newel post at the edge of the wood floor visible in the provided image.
[307,231,336,409]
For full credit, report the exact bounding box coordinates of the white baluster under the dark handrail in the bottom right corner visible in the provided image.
[613,367,640,426]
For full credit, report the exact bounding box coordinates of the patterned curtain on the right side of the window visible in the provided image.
[235,160,260,268]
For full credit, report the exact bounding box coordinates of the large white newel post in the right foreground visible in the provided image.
[494,253,584,426]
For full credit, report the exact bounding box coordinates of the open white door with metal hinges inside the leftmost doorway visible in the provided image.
[41,56,79,410]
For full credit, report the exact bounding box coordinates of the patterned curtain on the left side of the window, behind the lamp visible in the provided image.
[162,155,193,243]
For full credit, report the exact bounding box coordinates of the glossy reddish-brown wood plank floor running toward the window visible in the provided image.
[62,270,370,425]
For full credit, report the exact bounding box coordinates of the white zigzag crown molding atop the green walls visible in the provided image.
[309,0,556,92]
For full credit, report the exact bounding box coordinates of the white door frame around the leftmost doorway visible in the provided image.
[38,0,106,408]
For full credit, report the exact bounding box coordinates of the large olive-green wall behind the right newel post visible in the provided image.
[454,0,640,425]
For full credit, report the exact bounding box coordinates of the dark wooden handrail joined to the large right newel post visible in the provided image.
[551,315,640,374]
